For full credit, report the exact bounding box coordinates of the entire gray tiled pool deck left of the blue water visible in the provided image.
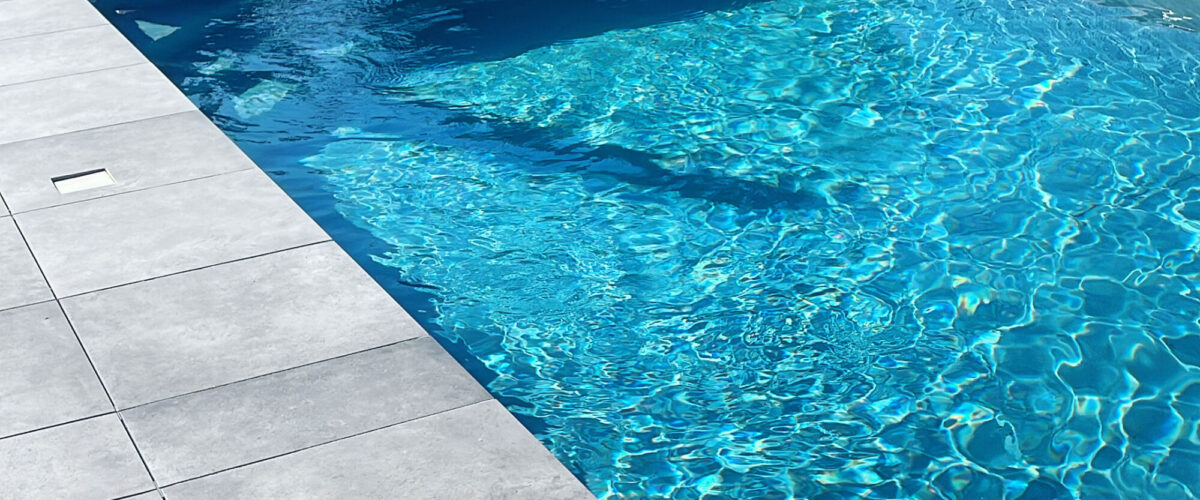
[0,0,592,499]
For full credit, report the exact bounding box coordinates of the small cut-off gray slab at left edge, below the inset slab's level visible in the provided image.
[0,217,54,311]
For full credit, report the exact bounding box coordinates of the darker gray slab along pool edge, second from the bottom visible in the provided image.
[122,337,491,484]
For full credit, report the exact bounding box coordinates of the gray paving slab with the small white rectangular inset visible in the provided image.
[0,110,257,212]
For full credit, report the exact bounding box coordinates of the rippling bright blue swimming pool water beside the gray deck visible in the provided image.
[97,0,1200,500]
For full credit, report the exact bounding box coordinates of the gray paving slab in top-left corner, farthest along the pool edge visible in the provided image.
[0,0,108,40]
